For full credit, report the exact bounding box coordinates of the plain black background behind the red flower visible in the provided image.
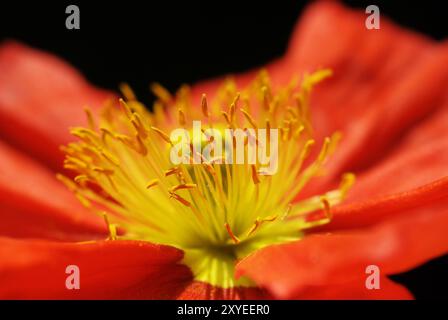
[0,0,448,298]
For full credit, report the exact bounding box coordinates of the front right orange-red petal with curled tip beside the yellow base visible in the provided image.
[237,208,448,298]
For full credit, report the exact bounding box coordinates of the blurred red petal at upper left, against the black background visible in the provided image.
[0,42,114,168]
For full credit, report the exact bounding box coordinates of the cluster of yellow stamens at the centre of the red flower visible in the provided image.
[58,70,354,288]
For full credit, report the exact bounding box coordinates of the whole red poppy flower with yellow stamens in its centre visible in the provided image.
[0,2,448,299]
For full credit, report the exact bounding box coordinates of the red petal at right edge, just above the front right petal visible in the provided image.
[323,105,448,230]
